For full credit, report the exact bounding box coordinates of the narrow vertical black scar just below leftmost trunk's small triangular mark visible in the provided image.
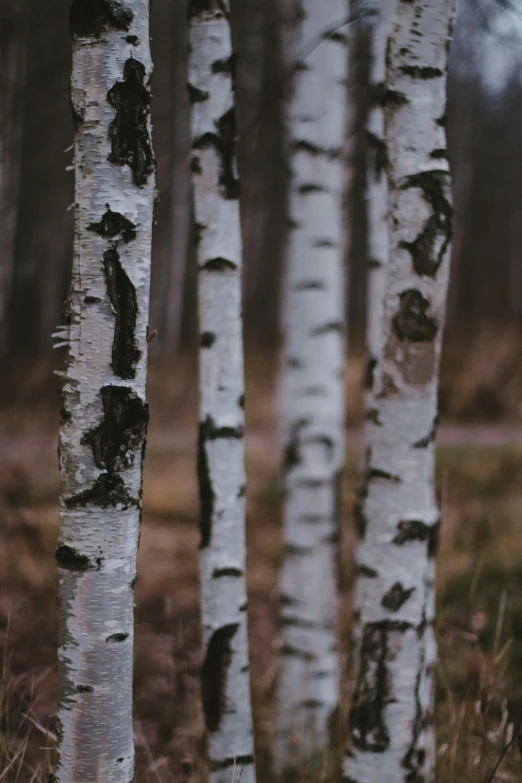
[103,248,141,380]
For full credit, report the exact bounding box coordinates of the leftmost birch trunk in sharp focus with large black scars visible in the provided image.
[56,0,155,783]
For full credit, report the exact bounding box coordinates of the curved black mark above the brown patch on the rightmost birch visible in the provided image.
[400,171,453,277]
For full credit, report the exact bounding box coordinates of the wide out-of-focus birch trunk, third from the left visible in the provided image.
[275,0,348,770]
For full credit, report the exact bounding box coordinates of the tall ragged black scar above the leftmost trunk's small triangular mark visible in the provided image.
[107,58,154,186]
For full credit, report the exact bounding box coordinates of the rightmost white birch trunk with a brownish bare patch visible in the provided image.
[344,0,454,783]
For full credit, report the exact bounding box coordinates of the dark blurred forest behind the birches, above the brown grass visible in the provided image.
[0,0,522,374]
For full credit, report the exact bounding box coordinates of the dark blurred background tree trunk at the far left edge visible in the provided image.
[0,0,27,357]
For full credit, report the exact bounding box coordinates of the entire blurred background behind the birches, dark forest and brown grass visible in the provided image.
[0,0,522,781]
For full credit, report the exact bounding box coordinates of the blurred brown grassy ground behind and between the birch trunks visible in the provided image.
[0,360,522,783]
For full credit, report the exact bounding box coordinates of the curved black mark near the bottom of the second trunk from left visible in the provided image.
[201,623,239,731]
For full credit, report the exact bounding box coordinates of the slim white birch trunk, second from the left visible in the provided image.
[189,0,255,783]
